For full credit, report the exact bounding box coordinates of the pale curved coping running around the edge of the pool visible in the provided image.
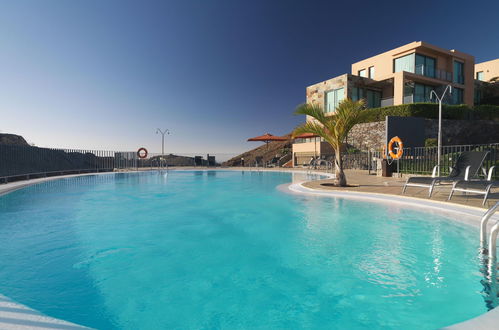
[0,168,499,330]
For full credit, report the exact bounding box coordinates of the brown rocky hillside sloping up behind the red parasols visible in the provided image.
[222,140,292,166]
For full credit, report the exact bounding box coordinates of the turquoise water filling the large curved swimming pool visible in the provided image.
[0,171,486,329]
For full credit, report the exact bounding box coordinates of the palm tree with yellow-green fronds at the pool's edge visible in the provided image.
[293,99,365,187]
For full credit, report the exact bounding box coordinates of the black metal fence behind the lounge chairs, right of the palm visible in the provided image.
[343,143,499,179]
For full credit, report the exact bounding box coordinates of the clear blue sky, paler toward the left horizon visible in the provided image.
[0,0,499,159]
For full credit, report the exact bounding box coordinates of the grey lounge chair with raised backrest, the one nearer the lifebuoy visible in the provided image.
[402,151,489,197]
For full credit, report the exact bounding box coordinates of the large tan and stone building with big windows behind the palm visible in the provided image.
[293,41,475,165]
